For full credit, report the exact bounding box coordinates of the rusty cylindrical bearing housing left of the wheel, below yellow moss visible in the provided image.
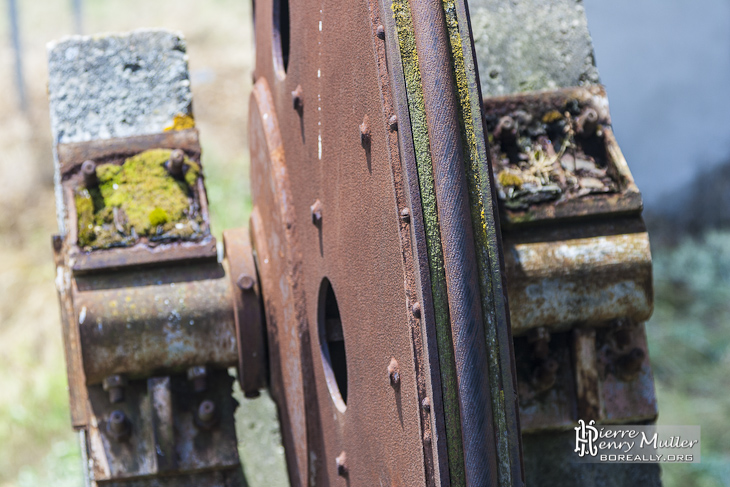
[69,263,236,384]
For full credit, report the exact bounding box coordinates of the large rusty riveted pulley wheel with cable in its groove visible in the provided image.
[249,0,523,486]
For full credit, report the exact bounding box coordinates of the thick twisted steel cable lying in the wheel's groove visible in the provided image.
[411,0,509,486]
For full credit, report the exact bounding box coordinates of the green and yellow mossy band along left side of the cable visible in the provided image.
[392,0,466,487]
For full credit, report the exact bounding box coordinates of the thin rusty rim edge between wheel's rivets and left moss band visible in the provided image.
[370,0,450,487]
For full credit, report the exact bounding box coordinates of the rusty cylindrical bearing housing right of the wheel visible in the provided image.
[504,222,653,335]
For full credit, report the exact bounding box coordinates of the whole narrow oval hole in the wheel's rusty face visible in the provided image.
[317,277,347,412]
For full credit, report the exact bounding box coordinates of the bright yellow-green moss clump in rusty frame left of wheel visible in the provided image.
[74,149,204,250]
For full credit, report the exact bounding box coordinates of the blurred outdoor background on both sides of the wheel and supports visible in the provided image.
[0,0,730,487]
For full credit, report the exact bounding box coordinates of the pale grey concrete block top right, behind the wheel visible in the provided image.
[469,0,598,97]
